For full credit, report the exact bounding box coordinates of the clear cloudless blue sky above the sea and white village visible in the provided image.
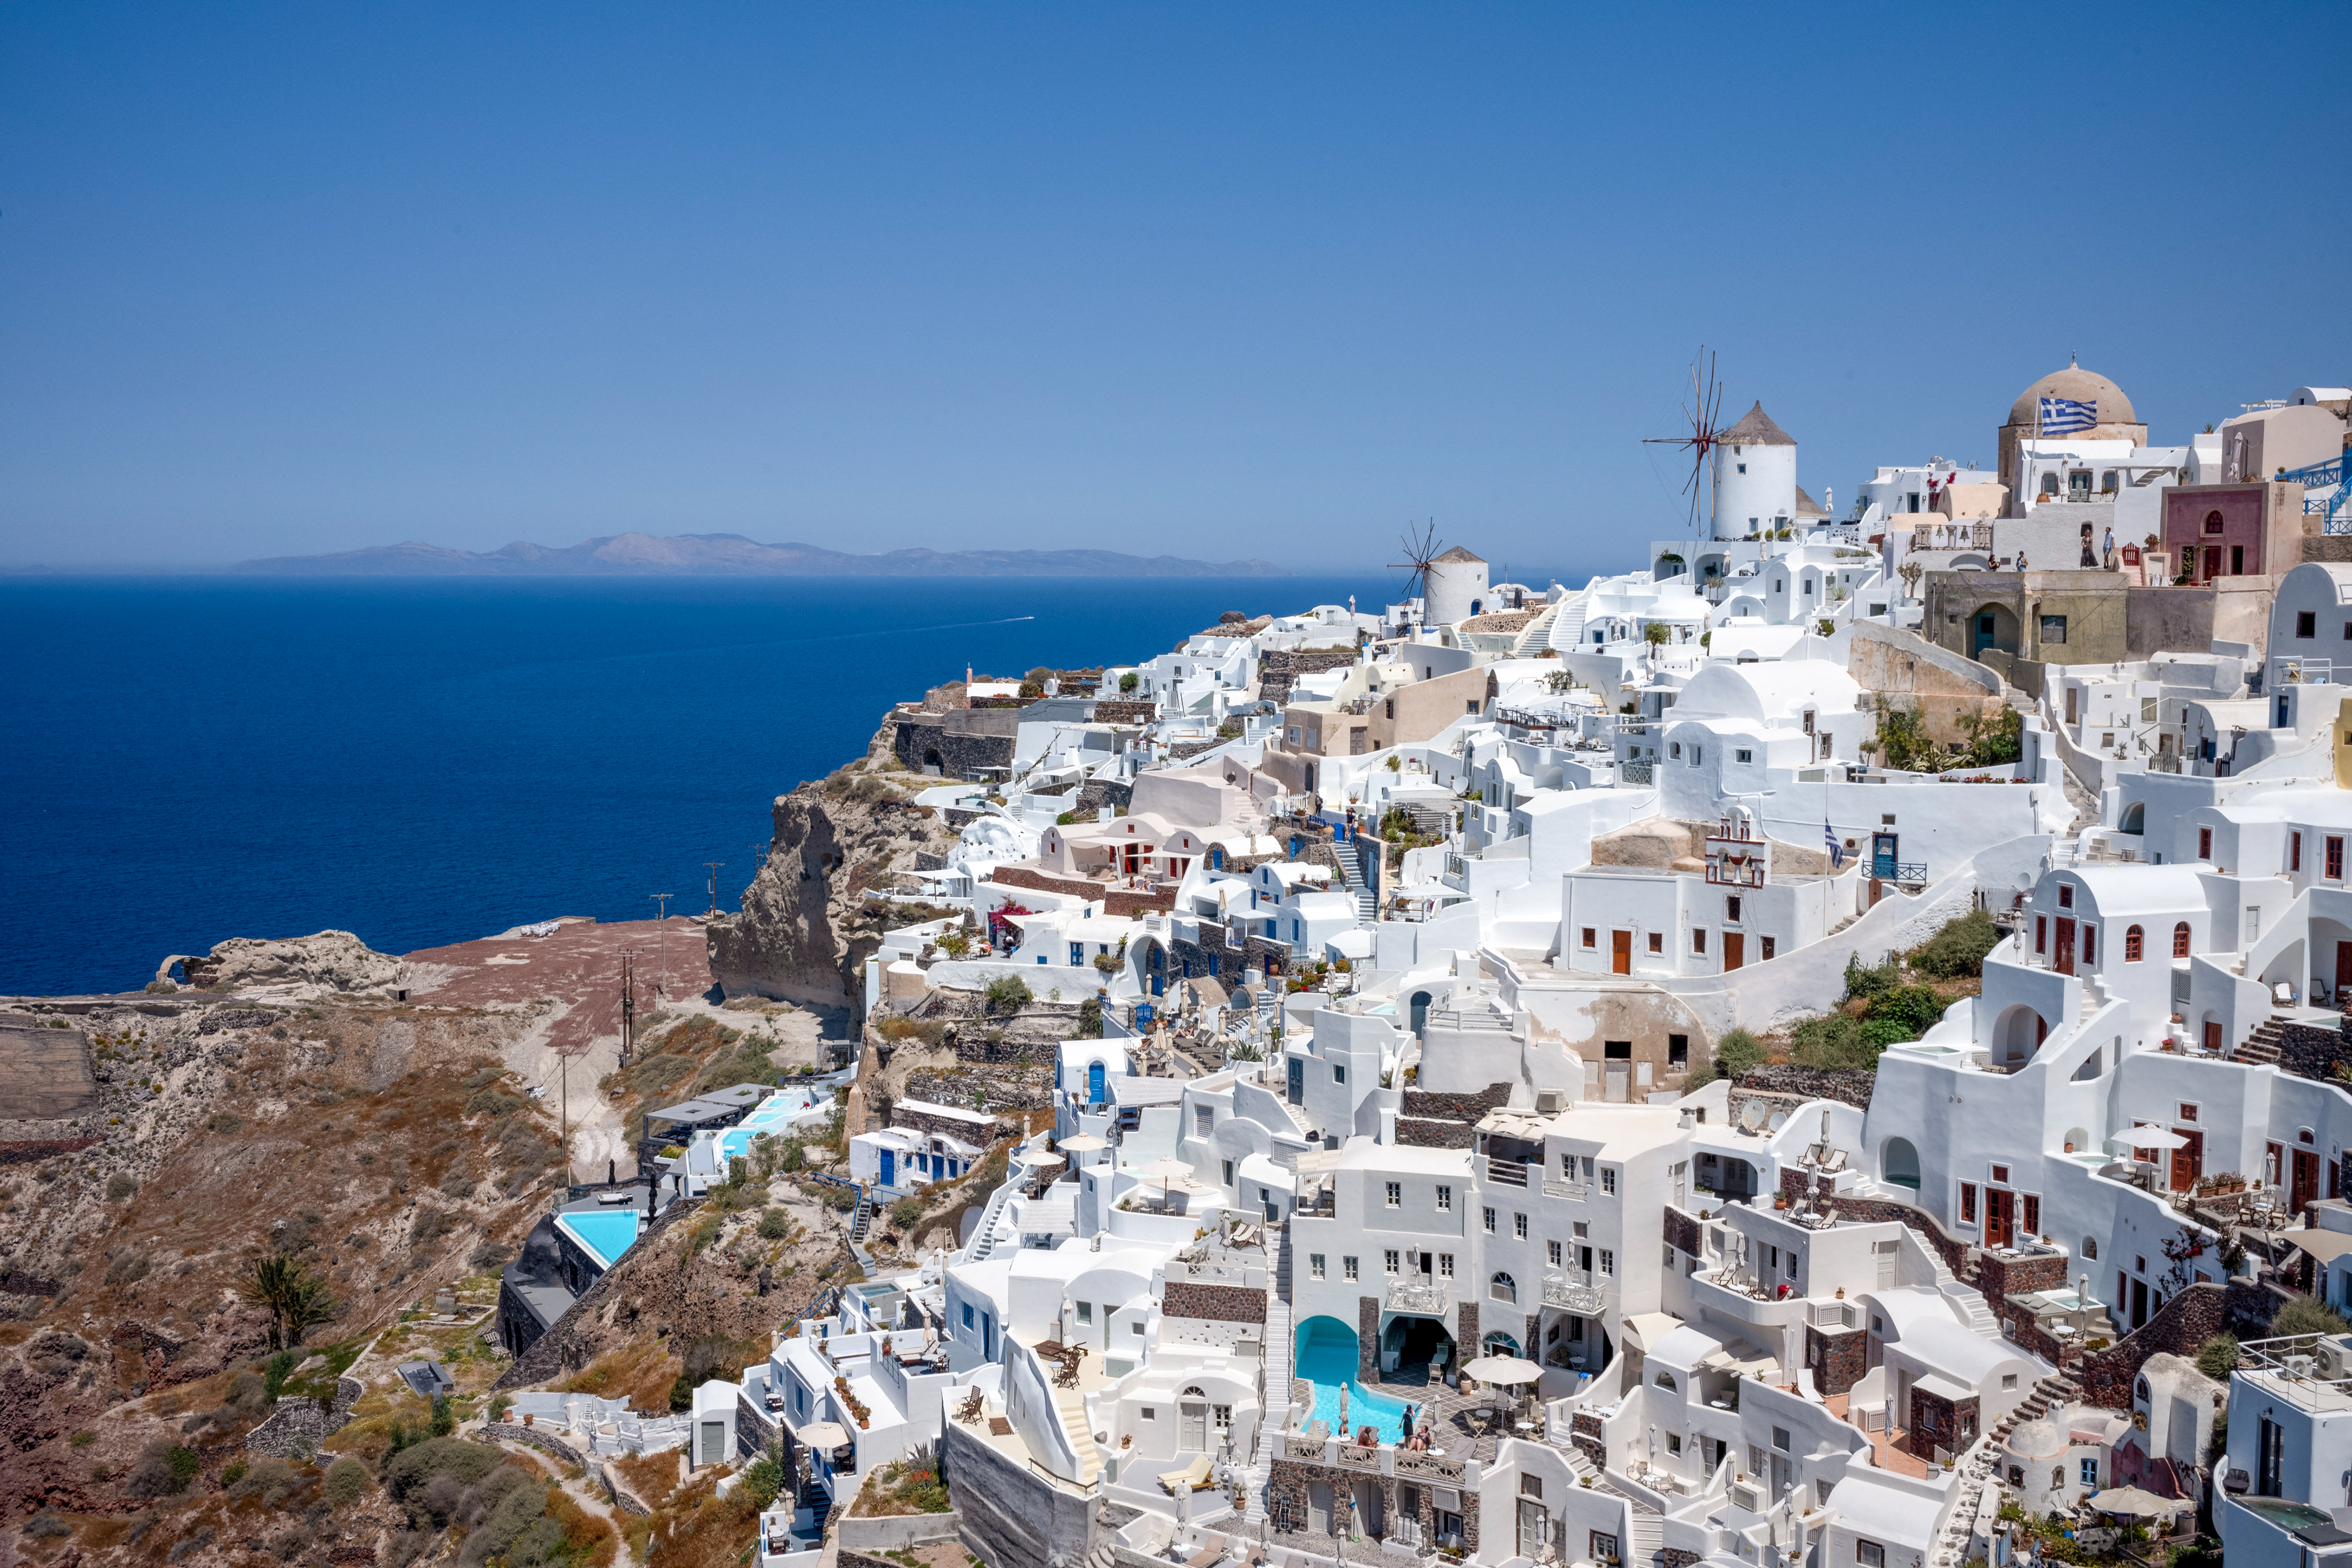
[0,2,2352,569]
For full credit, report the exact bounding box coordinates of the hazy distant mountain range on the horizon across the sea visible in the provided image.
[231,534,1291,576]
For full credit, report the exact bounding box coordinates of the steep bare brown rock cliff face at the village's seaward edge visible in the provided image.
[706,740,955,1009]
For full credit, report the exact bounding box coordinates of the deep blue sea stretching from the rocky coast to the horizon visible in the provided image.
[0,569,1585,994]
